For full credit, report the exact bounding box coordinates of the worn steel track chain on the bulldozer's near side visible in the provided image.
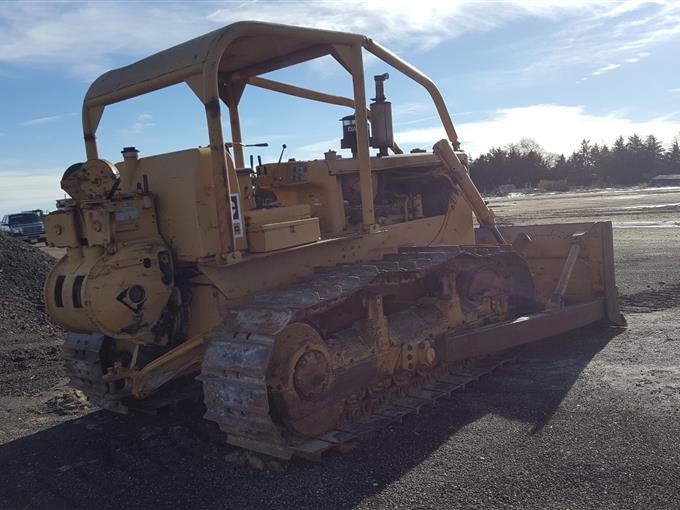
[199,246,506,458]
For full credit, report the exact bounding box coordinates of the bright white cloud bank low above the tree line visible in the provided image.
[388,104,680,156]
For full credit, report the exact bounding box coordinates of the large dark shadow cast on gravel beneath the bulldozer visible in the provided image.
[0,327,618,509]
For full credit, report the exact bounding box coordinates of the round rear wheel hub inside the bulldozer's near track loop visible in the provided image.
[267,322,343,437]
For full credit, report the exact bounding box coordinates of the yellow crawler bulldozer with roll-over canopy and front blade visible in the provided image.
[45,22,623,458]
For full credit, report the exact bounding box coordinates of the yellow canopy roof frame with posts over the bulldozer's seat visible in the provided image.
[82,21,459,263]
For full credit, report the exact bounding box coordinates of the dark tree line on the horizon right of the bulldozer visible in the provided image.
[470,135,680,192]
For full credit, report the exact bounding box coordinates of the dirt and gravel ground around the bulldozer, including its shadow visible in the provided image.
[0,188,680,509]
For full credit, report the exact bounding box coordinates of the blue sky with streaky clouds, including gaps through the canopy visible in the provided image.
[0,0,680,214]
